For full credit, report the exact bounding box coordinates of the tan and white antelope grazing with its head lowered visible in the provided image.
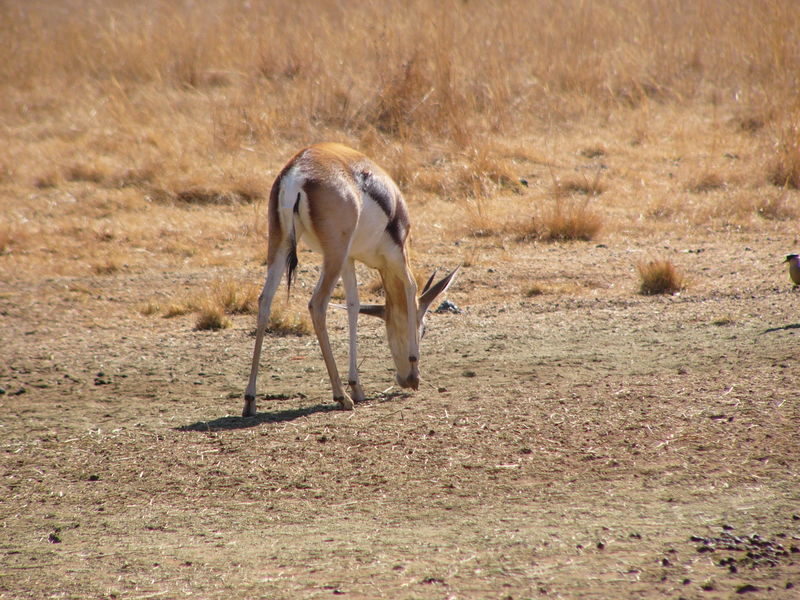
[242,143,458,417]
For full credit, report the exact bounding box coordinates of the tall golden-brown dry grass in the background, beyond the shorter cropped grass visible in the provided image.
[0,0,800,158]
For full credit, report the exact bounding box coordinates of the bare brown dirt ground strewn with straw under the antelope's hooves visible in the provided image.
[0,217,800,599]
